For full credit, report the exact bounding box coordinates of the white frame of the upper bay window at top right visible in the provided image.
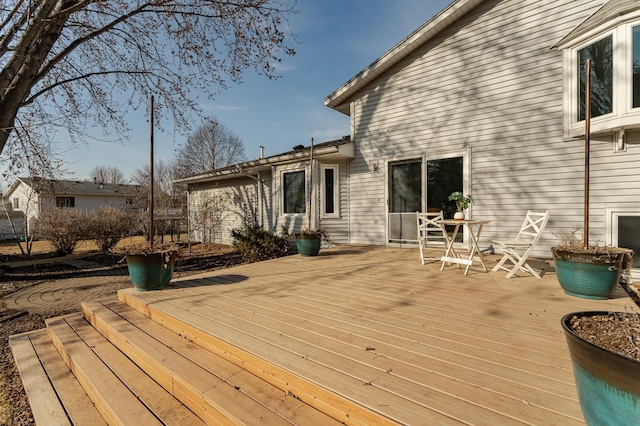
[563,11,640,142]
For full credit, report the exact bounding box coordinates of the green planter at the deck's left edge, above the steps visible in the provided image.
[126,253,175,291]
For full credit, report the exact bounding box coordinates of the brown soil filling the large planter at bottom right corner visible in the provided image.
[570,313,640,361]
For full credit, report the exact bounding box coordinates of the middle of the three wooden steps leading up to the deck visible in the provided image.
[46,314,203,425]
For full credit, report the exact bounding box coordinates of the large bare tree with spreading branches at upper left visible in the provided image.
[0,0,295,161]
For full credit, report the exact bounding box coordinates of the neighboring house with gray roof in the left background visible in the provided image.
[3,178,140,233]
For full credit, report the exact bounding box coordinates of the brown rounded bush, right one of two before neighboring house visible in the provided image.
[87,206,136,253]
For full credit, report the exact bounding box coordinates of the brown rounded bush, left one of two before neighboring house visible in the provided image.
[38,208,87,255]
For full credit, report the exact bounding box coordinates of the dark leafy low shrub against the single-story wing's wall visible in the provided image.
[231,225,291,262]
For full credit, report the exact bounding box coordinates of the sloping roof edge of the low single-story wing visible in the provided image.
[173,136,353,184]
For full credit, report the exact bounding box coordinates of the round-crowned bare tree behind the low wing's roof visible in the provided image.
[176,118,245,177]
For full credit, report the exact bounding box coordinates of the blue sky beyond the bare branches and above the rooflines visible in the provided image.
[59,0,451,179]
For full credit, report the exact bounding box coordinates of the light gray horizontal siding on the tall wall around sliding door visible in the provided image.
[350,0,608,257]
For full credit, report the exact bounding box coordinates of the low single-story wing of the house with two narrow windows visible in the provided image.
[175,137,354,244]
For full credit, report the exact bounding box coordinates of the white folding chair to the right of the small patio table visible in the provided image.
[491,210,551,278]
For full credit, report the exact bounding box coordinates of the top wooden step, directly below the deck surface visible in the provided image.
[82,299,337,424]
